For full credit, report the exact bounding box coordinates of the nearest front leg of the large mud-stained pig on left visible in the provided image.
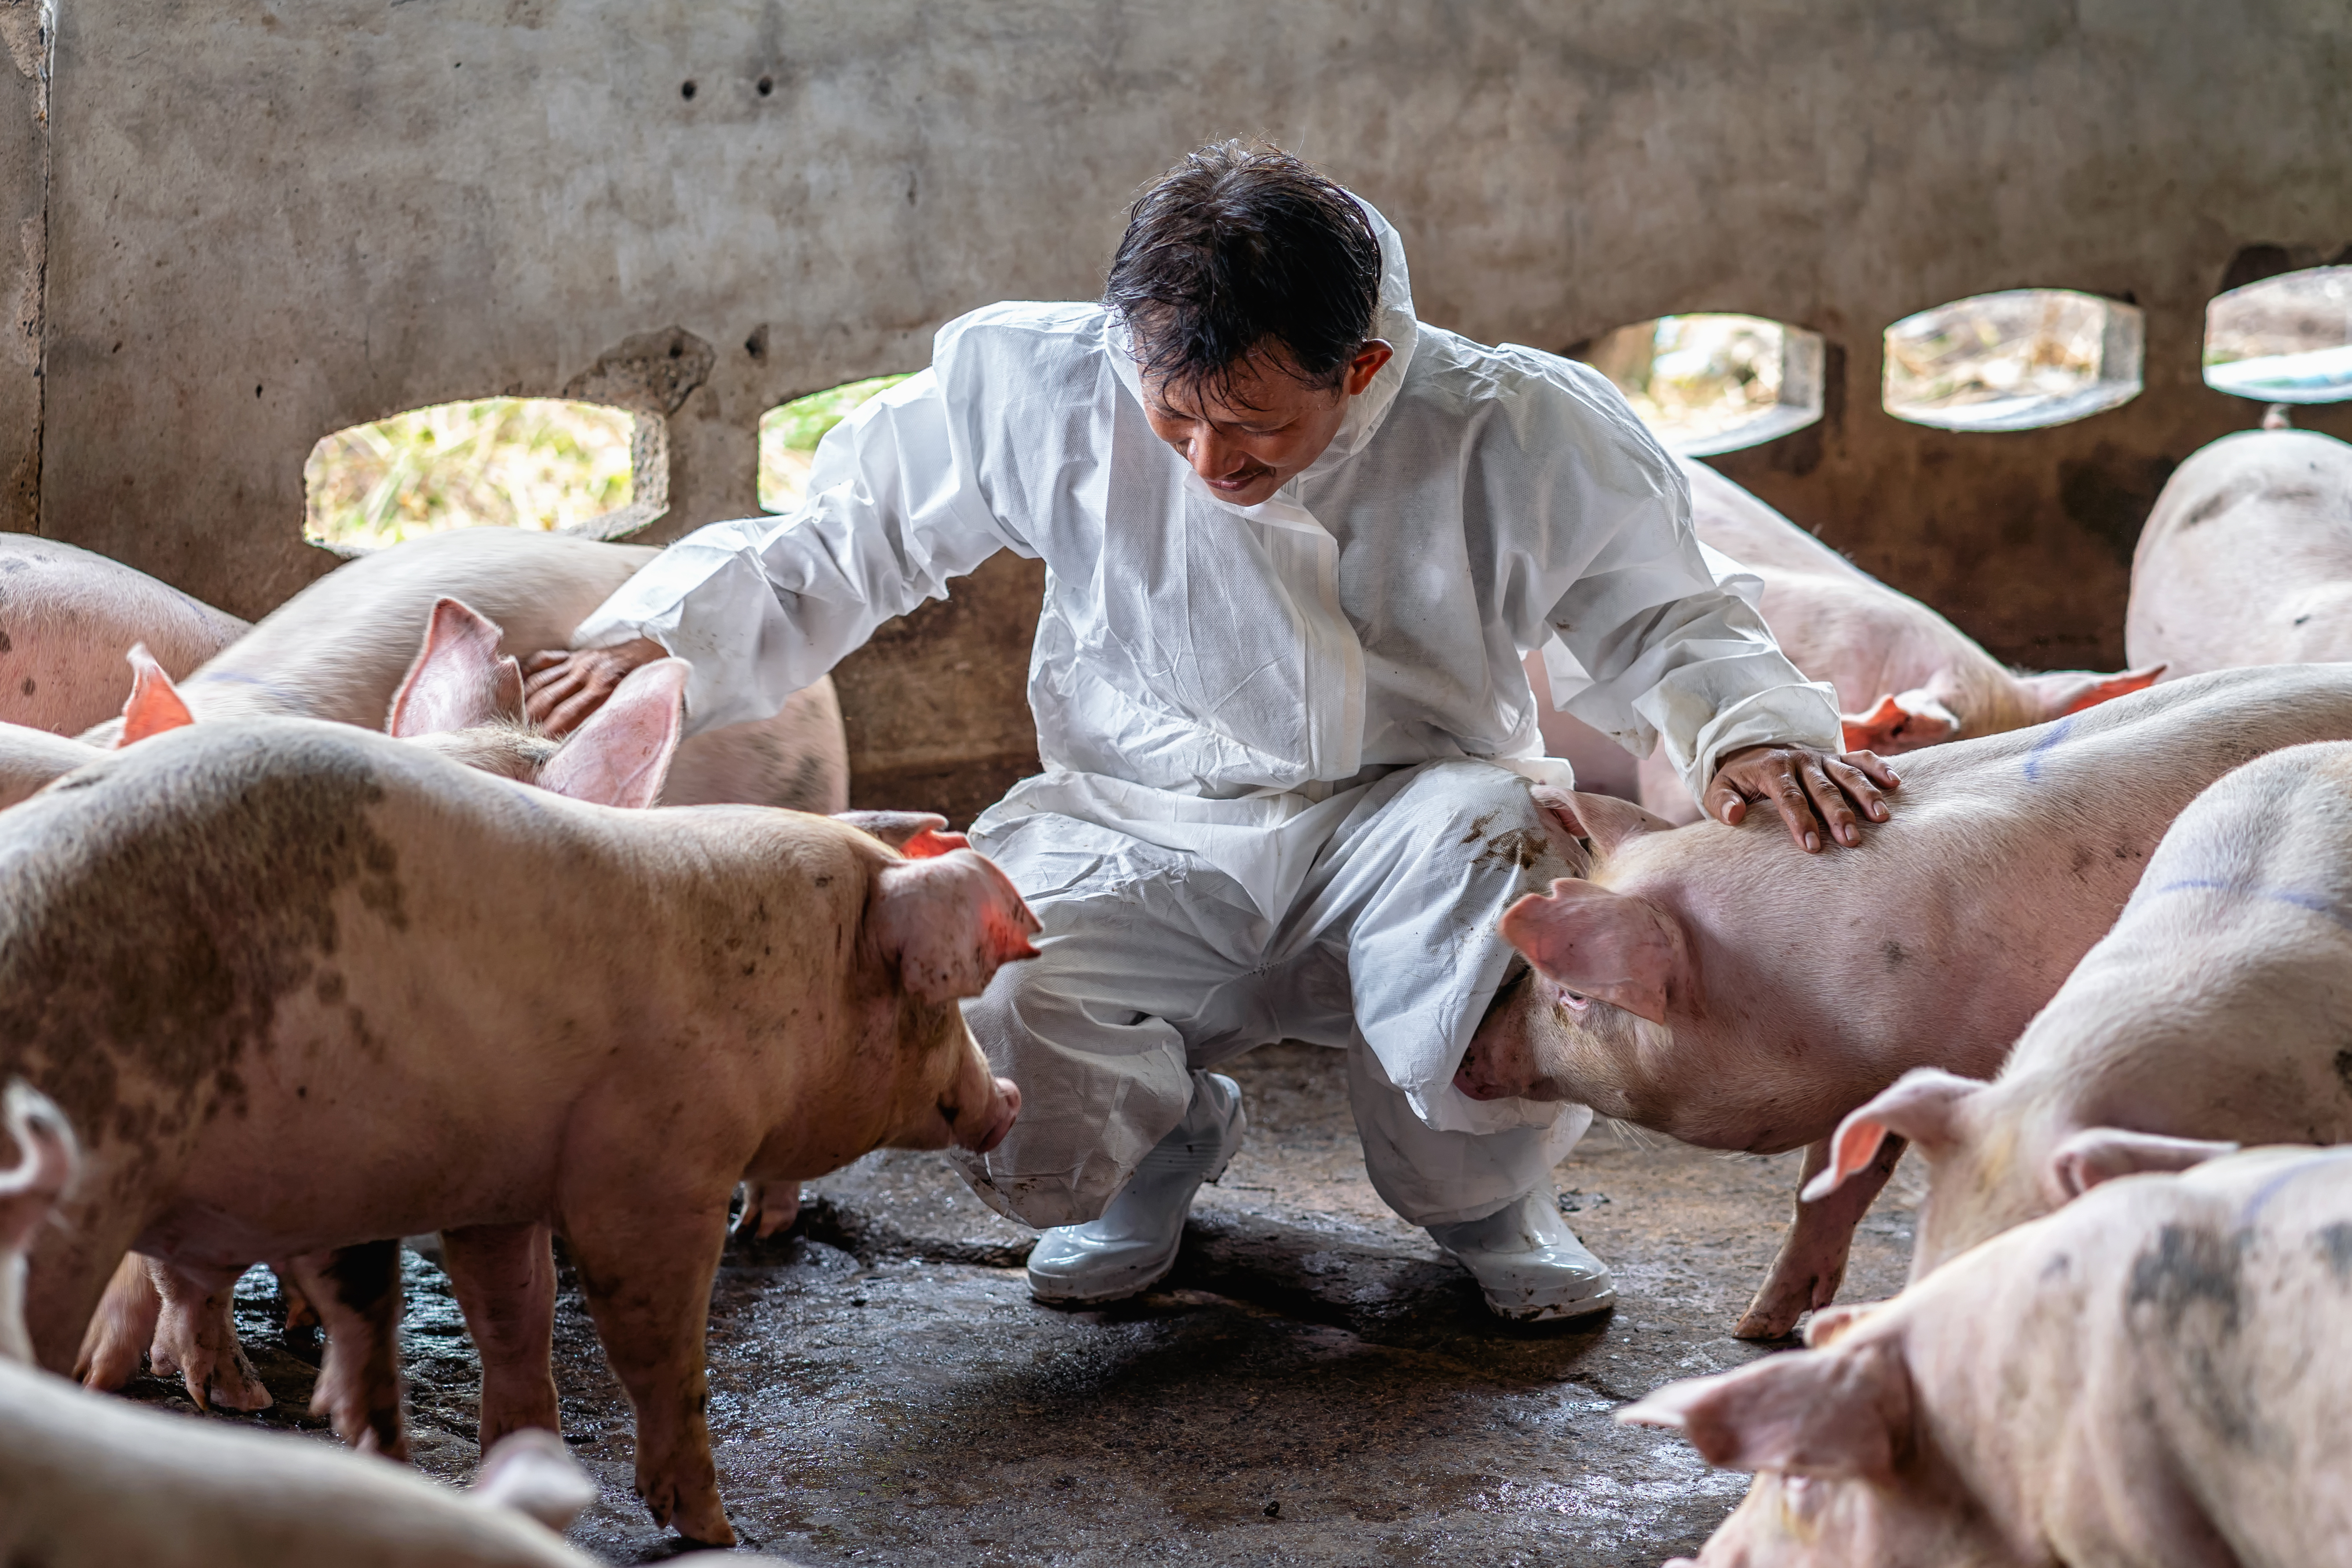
[564,1213,734,1547]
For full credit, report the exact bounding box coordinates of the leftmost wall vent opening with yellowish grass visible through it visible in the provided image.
[304,397,668,552]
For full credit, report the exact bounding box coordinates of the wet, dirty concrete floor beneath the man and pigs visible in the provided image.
[132,1046,1917,1568]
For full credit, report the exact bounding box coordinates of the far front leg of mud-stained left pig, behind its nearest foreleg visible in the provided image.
[442,1225,562,1453]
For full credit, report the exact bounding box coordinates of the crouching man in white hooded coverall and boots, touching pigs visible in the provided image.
[531,143,1893,1316]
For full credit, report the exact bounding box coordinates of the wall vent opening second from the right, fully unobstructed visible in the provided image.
[1882,289,2140,430]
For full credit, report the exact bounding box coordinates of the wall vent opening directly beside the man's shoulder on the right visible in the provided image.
[1583,313,1821,456]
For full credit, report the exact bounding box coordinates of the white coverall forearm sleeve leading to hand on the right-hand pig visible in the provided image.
[1545,439,1844,797]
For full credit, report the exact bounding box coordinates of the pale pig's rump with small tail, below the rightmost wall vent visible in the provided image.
[2124,430,2352,677]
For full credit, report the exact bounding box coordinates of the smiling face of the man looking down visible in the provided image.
[1143,339,1392,505]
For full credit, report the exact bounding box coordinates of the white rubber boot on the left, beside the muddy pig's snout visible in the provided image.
[1030,1072,1249,1305]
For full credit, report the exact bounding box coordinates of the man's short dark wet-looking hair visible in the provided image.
[1103,141,1381,409]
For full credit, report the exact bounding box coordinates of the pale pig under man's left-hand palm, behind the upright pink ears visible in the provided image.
[84,529,849,813]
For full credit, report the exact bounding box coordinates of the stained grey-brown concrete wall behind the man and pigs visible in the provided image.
[18,0,2352,811]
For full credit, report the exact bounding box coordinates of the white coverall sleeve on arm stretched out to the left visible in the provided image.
[571,369,1032,734]
